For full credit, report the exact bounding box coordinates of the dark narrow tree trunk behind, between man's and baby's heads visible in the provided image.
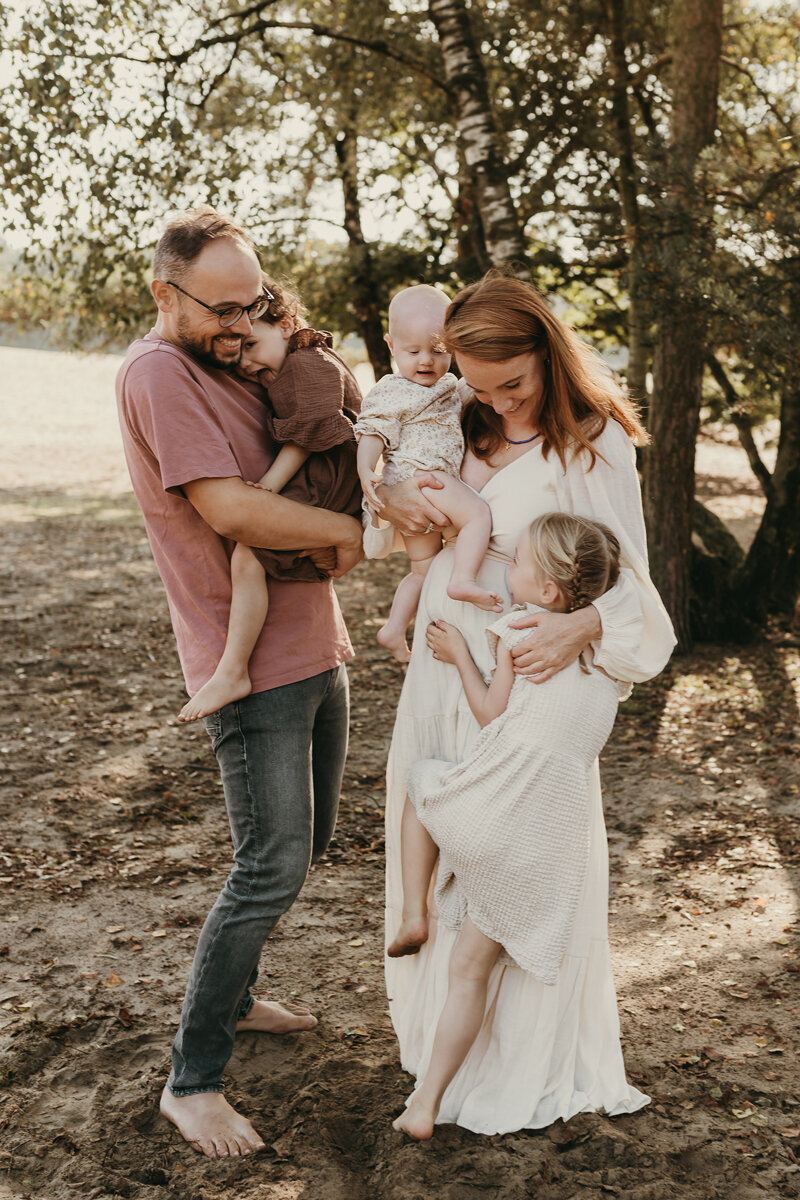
[333,128,392,379]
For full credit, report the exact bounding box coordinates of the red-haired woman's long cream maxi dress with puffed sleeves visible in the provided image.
[386,421,674,1134]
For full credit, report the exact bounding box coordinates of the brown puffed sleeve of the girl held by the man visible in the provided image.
[269,346,355,452]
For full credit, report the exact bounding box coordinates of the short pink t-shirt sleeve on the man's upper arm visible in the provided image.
[121,352,241,492]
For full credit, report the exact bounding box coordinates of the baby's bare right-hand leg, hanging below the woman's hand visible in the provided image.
[422,472,503,612]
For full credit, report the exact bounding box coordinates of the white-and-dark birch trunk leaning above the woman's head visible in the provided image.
[429,0,528,276]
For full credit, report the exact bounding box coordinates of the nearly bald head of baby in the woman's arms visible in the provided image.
[386,283,450,388]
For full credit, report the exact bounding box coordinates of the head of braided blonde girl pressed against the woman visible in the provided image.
[509,512,620,612]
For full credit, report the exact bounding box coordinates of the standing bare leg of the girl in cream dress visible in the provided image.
[392,917,501,1141]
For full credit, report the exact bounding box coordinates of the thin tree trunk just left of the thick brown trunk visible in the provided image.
[608,0,650,404]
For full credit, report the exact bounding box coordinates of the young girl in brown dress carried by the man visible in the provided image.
[179,276,361,721]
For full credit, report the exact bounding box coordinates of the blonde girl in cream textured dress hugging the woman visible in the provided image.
[389,512,627,1139]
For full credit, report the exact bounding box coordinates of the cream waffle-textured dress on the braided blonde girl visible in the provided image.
[408,605,627,984]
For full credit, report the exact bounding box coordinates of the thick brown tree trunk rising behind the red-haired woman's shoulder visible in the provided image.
[644,0,722,652]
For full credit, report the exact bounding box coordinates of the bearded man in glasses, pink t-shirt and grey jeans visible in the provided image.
[116,208,361,1158]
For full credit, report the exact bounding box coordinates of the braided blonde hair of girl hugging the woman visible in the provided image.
[528,512,619,612]
